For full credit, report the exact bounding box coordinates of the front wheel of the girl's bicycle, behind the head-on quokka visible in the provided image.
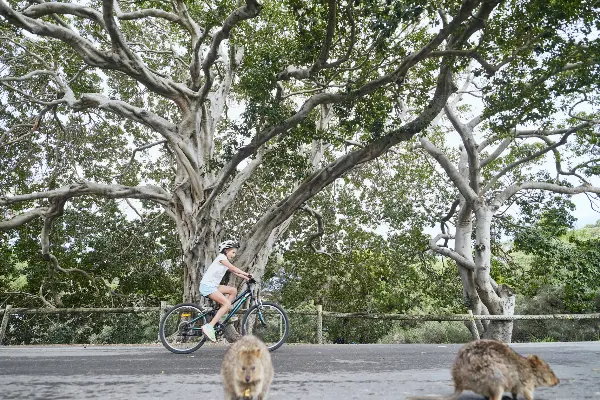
[242,302,290,351]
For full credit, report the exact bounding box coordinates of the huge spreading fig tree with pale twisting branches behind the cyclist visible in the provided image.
[0,0,510,301]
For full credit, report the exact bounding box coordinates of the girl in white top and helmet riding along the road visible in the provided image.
[200,240,252,342]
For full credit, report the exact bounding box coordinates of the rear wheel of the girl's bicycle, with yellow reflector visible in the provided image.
[158,303,207,354]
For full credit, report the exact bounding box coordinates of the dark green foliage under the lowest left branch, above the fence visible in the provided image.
[0,200,181,307]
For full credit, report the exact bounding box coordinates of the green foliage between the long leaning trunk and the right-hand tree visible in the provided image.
[265,148,464,343]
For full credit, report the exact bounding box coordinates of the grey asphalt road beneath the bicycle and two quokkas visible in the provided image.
[0,342,600,400]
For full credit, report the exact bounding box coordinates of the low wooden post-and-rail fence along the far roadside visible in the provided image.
[0,301,600,344]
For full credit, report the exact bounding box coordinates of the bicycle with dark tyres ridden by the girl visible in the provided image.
[158,279,290,354]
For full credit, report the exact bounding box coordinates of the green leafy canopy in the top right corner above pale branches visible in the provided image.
[479,0,600,132]
